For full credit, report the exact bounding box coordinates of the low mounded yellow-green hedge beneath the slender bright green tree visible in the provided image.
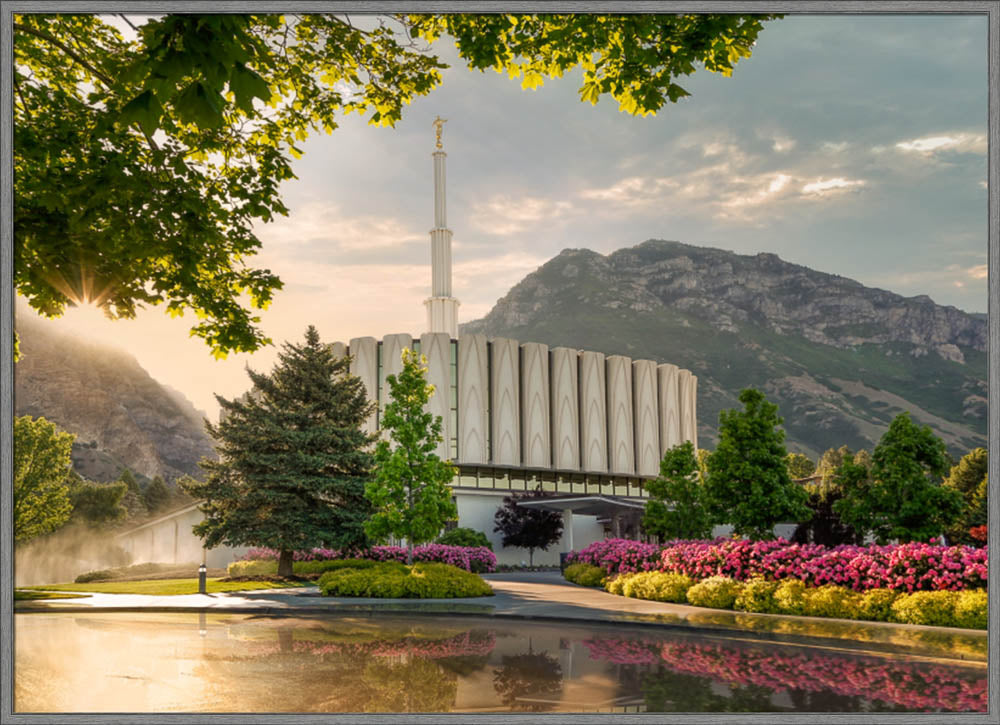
[319,561,493,599]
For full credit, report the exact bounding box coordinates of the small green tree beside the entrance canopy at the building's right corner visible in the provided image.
[642,441,713,541]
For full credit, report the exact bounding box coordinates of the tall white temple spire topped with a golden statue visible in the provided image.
[424,116,458,338]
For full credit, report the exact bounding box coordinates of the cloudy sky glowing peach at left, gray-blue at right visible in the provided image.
[18,15,988,419]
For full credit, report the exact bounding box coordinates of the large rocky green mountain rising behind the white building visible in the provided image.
[461,240,988,459]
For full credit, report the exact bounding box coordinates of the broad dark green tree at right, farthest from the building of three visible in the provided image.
[834,413,963,544]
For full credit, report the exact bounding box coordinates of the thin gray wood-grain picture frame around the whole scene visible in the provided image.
[0,0,1000,725]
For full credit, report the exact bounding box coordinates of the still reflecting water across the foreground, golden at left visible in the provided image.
[14,613,987,712]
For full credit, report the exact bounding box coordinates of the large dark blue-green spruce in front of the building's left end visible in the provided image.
[182,325,372,576]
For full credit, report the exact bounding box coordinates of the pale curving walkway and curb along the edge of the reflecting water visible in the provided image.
[14,572,987,662]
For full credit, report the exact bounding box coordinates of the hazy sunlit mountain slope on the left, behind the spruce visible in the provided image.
[14,314,215,483]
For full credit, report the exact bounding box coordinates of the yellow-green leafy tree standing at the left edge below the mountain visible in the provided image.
[13,415,75,542]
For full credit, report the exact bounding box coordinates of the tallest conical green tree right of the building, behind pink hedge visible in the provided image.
[705,388,809,539]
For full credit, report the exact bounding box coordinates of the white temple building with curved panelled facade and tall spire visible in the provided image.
[123,120,698,564]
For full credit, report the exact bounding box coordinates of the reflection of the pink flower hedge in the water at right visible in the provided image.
[584,639,987,712]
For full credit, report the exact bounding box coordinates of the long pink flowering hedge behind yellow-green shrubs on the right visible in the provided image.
[569,538,988,592]
